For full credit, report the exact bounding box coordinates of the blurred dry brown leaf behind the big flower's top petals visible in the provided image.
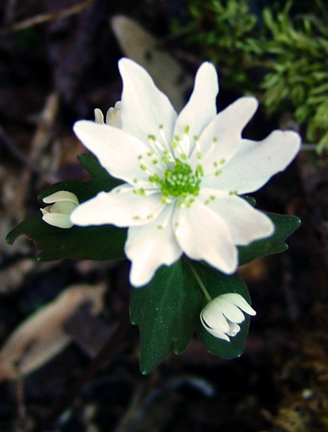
[111,15,192,111]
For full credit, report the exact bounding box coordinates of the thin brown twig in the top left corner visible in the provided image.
[0,0,94,34]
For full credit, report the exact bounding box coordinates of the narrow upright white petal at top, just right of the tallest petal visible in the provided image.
[174,62,219,156]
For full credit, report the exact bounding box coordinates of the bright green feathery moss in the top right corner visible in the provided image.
[173,0,328,151]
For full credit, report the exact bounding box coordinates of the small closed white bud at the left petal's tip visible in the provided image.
[40,191,79,228]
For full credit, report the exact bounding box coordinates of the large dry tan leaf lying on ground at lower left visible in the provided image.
[0,284,106,381]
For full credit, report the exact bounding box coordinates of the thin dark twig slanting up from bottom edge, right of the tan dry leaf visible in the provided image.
[32,311,130,432]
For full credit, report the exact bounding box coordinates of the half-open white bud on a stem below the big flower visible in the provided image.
[200,293,256,342]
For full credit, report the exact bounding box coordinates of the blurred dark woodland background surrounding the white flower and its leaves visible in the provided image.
[0,0,328,432]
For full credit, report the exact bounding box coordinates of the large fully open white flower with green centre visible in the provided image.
[71,59,300,287]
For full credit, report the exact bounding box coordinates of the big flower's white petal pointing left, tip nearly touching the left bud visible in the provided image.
[71,184,164,227]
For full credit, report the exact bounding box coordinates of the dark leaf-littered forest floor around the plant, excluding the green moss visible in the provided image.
[0,0,328,432]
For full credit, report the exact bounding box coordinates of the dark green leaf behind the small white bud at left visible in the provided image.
[6,179,127,261]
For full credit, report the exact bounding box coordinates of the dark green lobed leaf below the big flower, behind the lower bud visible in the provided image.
[130,259,250,374]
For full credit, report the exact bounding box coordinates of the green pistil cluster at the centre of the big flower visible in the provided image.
[149,159,202,200]
